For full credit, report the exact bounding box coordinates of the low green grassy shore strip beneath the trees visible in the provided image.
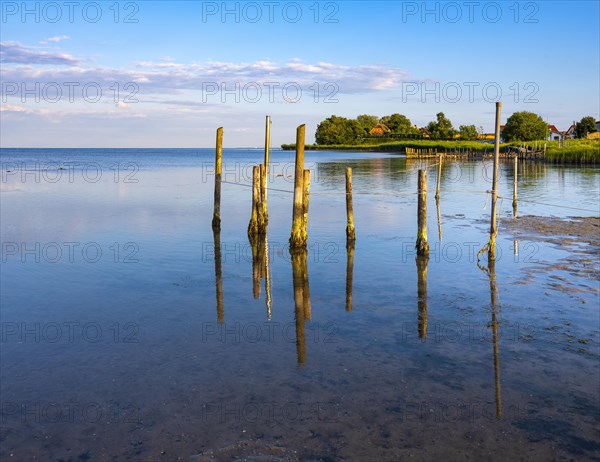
[281,139,600,165]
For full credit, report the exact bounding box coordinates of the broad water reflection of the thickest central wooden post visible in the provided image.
[290,248,310,366]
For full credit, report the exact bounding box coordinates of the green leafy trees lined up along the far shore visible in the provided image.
[315,111,596,145]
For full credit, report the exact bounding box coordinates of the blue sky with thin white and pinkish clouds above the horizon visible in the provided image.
[0,0,600,148]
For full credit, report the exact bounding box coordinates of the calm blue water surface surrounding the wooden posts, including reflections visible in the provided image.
[0,149,600,461]
